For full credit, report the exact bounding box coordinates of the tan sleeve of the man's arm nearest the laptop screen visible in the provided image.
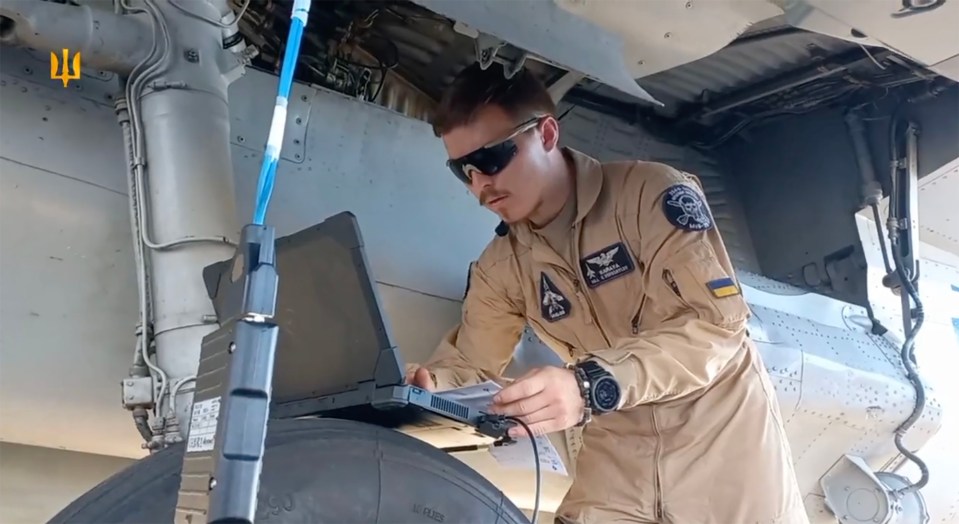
[423,256,525,390]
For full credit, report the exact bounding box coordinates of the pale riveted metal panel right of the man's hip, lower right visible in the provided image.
[740,272,942,502]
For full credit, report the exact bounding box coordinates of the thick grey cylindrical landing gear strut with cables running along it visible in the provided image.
[120,3,249,439]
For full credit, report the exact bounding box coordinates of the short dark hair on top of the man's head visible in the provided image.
[432,62,556,136]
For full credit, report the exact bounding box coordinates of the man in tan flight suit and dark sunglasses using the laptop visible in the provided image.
[407,64,808,524]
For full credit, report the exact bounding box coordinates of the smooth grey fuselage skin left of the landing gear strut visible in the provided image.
[0,73,142,456]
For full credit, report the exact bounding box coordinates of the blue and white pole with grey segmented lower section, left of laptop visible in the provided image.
[207,0,310,524]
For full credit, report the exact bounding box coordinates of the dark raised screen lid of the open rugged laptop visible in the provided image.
[207,212,402,402]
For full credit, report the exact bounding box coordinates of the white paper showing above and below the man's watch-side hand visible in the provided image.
[437,381,569,476]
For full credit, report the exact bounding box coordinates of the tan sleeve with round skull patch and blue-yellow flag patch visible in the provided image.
[591,165,749,409]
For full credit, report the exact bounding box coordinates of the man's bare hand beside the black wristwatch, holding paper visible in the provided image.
[490,366,584,437]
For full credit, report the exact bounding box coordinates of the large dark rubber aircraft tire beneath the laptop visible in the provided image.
[50,418,529,524]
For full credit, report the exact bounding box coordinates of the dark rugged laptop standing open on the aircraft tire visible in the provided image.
[204,212,505,438]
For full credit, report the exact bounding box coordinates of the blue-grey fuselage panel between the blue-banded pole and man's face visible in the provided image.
[233,85,498,301]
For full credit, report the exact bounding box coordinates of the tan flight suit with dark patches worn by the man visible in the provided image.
[424,149,808,524]
